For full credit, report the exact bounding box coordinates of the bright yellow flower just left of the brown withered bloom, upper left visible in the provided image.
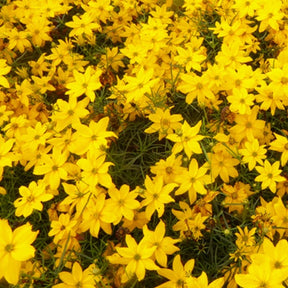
[66,66,102,102]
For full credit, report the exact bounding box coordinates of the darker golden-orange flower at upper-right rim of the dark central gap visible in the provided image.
[144,108,183,140]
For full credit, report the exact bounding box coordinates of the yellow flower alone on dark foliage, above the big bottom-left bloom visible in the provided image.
[14,181,53,217]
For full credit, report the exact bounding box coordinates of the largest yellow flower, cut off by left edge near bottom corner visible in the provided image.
[0,219,38,285]
